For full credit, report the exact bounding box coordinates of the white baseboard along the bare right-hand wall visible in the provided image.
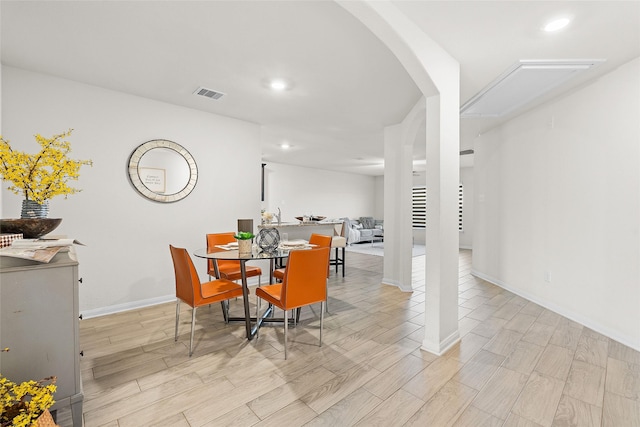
[471,269,640,351]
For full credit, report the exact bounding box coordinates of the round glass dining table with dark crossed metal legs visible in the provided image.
[193,245,296,340]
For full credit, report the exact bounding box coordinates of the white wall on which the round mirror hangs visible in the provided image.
[2,67,262,315]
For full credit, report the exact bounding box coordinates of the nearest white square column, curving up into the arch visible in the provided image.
[337,0,460,355]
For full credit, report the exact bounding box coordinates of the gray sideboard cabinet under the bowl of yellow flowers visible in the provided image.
[0,247,84,427]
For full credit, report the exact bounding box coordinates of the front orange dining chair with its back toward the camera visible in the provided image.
[256,247,331,359]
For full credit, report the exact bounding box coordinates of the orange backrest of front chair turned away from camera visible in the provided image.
[281,247,331,309]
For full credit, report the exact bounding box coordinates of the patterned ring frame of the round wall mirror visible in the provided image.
[124,139,198,203]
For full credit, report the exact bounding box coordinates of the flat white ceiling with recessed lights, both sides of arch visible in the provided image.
[0,0,640,175]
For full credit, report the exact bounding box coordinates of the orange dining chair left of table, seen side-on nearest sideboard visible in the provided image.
[169,245,242,357]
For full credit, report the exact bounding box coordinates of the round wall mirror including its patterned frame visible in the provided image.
[129,139,198,203]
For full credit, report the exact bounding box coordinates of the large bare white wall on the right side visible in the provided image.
[473,59,640,350]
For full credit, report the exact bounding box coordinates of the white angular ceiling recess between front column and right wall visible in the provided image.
[460,59,604,118]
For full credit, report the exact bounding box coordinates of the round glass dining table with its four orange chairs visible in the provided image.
[169,226,340,359]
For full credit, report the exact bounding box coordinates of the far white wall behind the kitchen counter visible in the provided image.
[263,162,376,222]
